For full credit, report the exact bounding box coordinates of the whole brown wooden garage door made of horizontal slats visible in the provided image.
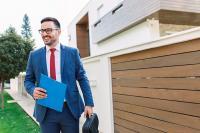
[111,38,200,133]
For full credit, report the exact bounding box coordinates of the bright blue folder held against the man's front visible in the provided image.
[36,74,67,112]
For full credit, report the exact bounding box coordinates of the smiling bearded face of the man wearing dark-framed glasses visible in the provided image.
[40,21,61,46]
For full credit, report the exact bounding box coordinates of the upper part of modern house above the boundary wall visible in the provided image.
[68,0,200,57]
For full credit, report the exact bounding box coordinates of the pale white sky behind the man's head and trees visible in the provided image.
[0,0,89,47]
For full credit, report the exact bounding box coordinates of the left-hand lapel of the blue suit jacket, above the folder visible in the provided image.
[41,47,48,76]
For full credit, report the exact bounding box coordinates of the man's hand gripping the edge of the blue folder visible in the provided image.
[33,87,47,99]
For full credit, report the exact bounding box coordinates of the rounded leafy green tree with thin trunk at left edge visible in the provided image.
[0,27,32,108]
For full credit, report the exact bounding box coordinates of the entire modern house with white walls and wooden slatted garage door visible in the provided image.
[68,0,200,133]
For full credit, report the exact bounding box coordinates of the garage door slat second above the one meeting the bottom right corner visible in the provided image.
[113,94,200,117]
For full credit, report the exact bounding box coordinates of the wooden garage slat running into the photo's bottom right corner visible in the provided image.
[114,110,200,133]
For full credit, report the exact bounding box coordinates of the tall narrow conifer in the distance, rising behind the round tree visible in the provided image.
[21,14,32,40]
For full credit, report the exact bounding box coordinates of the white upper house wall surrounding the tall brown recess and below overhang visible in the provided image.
[68,0,160,56]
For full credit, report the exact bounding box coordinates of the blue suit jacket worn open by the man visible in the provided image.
[24,45,94,122]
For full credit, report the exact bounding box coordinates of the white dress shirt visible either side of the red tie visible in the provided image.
[46,43,61,82]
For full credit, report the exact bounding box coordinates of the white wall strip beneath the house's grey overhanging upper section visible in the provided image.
[90,20,160,56]
